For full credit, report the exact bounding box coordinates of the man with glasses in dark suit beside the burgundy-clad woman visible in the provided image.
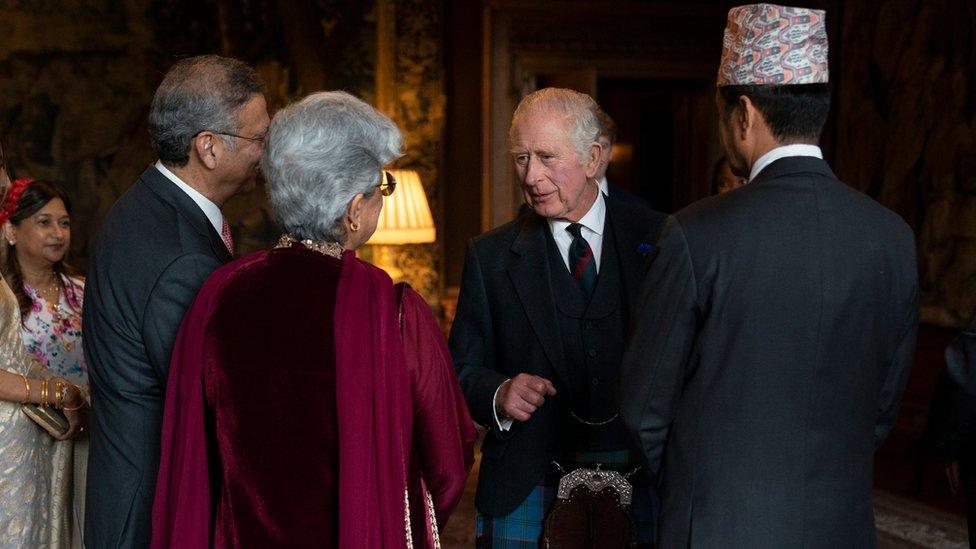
[83,56,269,547]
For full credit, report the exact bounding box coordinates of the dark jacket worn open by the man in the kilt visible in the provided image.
[450,198,664,516]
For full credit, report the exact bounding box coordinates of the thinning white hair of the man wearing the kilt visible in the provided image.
[508,88,601,165]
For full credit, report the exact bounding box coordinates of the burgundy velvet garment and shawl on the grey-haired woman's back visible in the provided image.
[152,246,473,548]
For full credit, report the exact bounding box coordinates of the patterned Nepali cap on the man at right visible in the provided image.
[717,4,828,86]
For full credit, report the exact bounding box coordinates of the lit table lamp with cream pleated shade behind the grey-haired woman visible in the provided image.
[366,166,437,280]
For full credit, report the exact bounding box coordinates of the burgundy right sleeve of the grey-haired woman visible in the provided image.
[402,288,476,527]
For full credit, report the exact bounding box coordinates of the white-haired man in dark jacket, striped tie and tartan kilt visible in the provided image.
[450,88,664,547]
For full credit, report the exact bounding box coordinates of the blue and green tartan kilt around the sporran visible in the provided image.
[475,450,660,549]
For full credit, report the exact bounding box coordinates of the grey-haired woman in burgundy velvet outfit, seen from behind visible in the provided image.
[153,92,474,548]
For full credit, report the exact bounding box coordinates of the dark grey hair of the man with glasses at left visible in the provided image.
[149,55,261,166]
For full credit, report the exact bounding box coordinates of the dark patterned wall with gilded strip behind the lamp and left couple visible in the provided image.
[0,0,445,308]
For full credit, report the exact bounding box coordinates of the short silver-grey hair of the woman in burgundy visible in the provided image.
[261,92,403,243]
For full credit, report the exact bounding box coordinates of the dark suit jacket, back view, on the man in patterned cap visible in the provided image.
[620,157,918,547]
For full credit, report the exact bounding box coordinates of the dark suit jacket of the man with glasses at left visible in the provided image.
[83,167,230,548]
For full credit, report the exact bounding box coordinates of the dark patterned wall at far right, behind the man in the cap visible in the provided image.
[832,0,976,327]
